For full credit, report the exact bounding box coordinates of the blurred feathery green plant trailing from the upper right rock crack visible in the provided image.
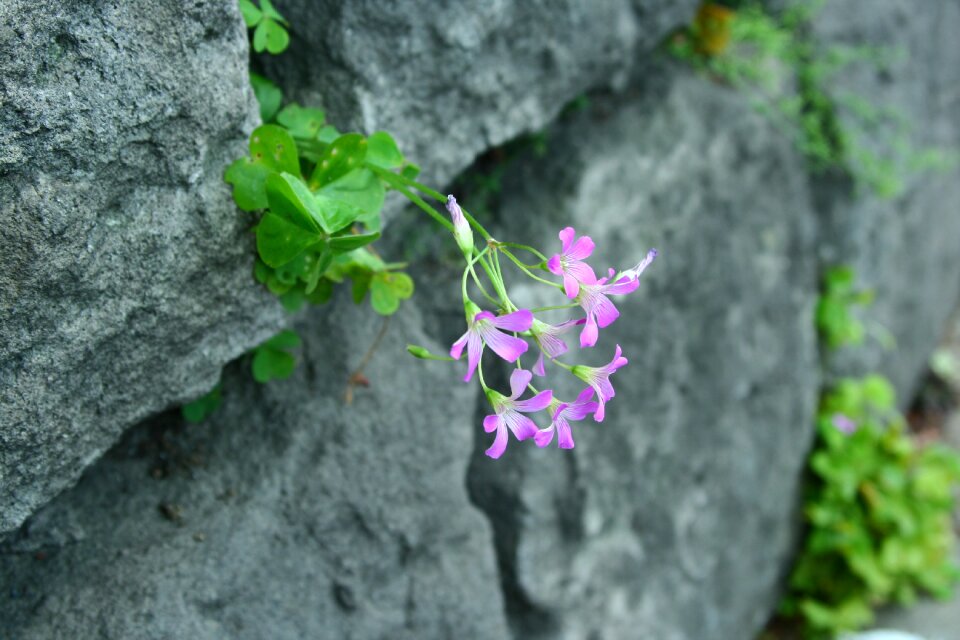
[668,0,955,198]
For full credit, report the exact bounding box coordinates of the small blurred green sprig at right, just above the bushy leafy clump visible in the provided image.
[816,266,873,349]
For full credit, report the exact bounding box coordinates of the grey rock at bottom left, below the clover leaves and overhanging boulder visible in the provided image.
[0,298,508,640]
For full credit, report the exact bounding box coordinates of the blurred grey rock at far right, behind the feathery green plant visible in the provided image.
[814,0,960,403]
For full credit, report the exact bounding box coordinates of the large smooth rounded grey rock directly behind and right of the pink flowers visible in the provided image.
[470,60,820,640]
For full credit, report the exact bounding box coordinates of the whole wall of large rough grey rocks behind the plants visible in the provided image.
[0,0,960,640]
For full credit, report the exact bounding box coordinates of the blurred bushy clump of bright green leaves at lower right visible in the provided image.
[781,375,960,638]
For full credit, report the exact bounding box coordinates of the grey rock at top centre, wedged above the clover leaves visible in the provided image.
[267,0,699,184]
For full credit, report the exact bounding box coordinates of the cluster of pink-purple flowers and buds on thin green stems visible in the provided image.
[436,214,657,458]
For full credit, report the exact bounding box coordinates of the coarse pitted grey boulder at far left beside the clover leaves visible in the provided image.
[0,0,281,532]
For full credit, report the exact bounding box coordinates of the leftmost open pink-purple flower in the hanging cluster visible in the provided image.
[450,303,533,382]
